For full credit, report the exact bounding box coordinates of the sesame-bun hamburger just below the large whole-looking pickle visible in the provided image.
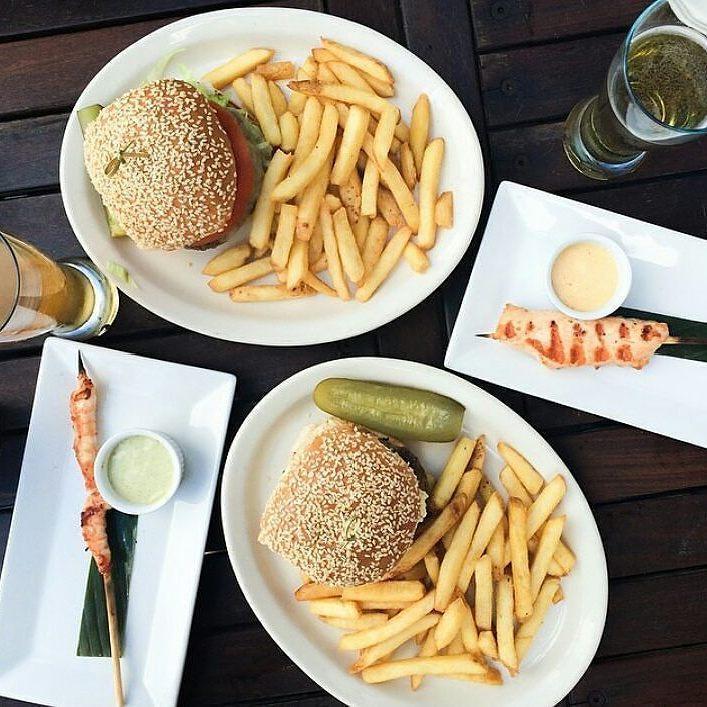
[258,418,426,587]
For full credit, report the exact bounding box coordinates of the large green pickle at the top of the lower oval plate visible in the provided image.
[314,378,464,442]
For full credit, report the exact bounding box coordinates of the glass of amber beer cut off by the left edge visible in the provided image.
[0,231,118,343]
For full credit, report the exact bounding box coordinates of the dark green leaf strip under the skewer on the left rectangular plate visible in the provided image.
[76,509,137,658]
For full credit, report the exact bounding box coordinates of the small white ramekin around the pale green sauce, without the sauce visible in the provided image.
[93,429,184,515]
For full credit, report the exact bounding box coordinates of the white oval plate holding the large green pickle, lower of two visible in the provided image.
[221,358,608,707]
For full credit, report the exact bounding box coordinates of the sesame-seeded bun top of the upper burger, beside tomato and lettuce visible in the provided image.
[84,79,236,250]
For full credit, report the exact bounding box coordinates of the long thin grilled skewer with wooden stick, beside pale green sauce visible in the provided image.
[69,353,125,707]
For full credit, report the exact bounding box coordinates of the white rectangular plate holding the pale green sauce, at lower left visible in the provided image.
[0,339,236,707]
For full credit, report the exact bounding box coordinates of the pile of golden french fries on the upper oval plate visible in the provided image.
[202,38,454,302]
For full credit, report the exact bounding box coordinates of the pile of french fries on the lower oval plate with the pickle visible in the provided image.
[295,436,576,690]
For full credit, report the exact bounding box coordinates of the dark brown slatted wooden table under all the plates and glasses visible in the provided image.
[0,0,707,707]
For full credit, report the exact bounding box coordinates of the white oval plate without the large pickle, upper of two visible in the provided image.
[59,8,484,346]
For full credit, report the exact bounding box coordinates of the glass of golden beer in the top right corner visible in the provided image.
[563,0,707,179]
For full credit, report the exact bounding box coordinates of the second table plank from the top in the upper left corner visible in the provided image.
[0,0,320,119]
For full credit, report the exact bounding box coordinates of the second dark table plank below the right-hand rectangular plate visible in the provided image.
[595,490,707,577]
